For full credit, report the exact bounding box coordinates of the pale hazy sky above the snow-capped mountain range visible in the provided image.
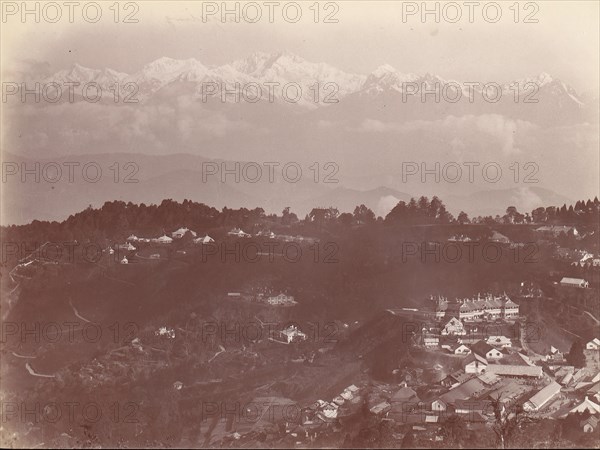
[2,1,600,93]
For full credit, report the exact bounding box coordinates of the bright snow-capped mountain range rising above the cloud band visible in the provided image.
[34,51,585,108]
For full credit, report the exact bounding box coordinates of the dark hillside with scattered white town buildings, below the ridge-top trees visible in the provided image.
[3,197,600,448]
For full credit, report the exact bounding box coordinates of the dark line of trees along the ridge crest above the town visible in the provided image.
[0,196,600,250]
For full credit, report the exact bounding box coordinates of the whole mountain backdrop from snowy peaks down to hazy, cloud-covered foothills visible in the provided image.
[2,52,600,223]
